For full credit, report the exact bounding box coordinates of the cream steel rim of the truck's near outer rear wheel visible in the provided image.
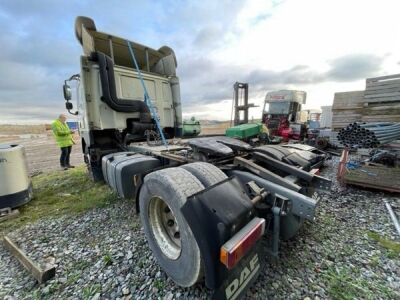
[149,197,181,260]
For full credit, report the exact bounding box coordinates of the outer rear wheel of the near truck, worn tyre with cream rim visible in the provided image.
[139,168,204,287]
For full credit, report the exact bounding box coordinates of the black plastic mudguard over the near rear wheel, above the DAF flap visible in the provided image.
[181,177,255,290]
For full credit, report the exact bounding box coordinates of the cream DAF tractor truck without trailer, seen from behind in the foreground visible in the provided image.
[64,17,330,299]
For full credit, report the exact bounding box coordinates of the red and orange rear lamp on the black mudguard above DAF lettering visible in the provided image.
[220,218,265,269]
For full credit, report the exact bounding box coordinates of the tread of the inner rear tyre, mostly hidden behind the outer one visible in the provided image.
[181,162,228,188]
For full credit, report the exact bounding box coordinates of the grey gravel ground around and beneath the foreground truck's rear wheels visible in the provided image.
[0,159,400,300]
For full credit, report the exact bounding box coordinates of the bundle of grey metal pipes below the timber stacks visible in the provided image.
[338,122,400,148]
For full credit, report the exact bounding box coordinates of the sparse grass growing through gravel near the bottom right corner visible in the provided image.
[323,267,394,300]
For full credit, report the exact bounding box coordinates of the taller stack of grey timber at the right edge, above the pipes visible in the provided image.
[361,74,400,122]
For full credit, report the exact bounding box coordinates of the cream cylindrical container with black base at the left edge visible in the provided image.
[0,144,32,209]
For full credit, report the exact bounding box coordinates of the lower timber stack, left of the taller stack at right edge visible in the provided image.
[332,91,364,130]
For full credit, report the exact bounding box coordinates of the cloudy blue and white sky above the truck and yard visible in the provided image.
[0,0,400,123]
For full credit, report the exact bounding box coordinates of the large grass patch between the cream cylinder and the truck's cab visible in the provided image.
[0,166,118,235]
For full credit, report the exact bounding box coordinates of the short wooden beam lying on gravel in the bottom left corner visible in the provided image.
[3,236,56,283]
